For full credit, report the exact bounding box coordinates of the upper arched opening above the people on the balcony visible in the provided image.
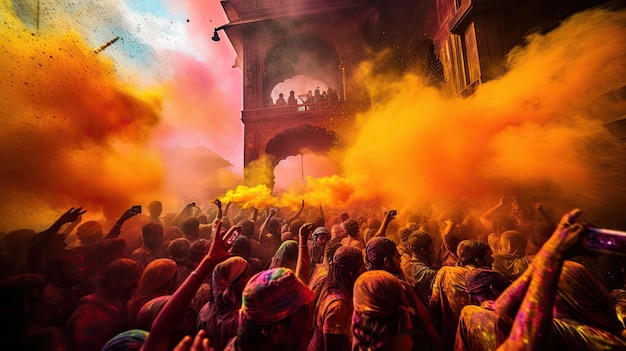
[263,34,341,107]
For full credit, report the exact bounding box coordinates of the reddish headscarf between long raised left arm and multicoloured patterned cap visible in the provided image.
[212,256,248,314]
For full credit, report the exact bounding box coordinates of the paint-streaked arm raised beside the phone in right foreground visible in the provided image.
[498,209,585,351]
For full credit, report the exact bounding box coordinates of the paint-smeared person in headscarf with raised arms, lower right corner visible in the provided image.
[495,209,626,351]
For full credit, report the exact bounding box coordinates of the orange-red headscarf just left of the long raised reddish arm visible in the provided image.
[128,258,176,323]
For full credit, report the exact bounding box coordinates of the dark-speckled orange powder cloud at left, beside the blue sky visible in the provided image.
[0,1,162,230]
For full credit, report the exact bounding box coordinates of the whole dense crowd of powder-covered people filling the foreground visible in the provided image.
[0,196,626,351]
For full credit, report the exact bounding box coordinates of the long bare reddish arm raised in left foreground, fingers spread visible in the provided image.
[141,221,230,351]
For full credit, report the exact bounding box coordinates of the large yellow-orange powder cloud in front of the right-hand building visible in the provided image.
[344,10,626,226]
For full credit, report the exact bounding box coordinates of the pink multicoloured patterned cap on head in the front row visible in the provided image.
[240,267,315,325]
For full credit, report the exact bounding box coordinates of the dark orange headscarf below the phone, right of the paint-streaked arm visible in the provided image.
[555,261,621,335]
